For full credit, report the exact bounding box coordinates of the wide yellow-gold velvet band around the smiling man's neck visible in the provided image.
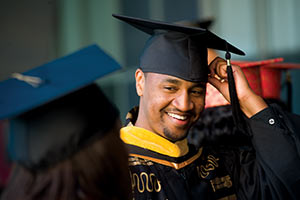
[120,126,189,158]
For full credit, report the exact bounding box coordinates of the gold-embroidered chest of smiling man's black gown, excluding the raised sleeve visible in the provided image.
[129,146,235,200]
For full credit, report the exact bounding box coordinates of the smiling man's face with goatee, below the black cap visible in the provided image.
[135,69,206,142]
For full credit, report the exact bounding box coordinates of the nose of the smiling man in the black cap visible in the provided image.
[173,91,194,112]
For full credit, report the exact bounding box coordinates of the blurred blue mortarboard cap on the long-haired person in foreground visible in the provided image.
[0,45,120,169]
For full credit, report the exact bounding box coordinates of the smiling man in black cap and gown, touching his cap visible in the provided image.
[114,15,300,200]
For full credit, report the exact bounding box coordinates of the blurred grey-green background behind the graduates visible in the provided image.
[0,0,300,119]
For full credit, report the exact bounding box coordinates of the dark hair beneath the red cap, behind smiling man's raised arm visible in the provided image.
[188,99,287,148]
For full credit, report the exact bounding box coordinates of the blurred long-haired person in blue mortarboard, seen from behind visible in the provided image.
[0,45,130,200]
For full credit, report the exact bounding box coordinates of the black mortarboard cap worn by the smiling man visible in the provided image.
[113,14,245,82]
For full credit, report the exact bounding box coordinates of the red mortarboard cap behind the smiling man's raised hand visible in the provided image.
[205,58,300,108]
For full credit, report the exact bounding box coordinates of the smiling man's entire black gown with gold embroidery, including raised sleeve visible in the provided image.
[122,106,300,200]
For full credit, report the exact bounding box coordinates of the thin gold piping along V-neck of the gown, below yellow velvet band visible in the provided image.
[129,148,202,169]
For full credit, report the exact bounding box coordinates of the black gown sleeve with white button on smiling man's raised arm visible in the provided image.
[223,105,300,199]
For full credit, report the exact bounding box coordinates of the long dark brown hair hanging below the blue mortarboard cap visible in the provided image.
[1,119,131,200]
